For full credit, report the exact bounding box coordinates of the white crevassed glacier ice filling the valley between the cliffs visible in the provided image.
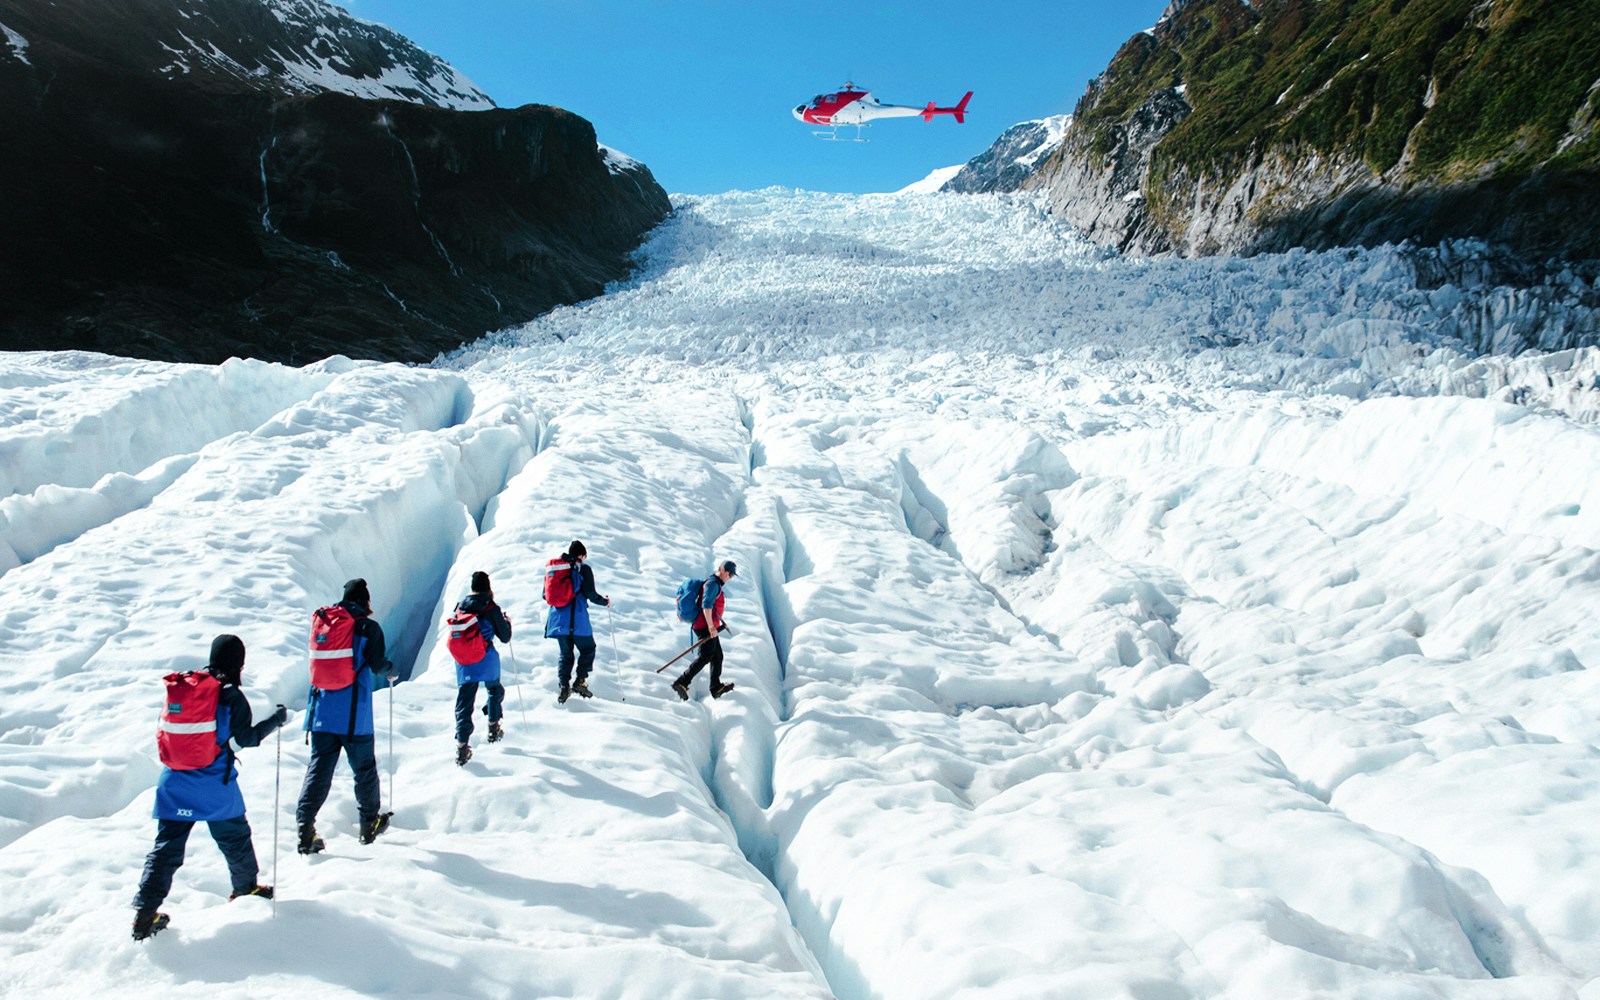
[0,189,1600,1000]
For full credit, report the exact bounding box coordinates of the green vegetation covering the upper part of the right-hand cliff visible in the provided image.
[1077,0,1600,186]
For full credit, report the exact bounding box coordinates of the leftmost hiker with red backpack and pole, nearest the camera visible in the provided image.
[133,635,290,941]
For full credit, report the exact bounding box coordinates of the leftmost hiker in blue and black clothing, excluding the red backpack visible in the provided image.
[133,635,290,941]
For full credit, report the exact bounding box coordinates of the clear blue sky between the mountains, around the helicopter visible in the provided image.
[338,0,1168,194]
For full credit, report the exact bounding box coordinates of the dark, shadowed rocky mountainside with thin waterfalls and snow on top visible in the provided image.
[0,0,670,362]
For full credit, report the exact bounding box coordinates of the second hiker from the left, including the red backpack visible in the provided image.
[294,579,394,854]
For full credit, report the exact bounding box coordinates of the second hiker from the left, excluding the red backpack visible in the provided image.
[294,579,394,854]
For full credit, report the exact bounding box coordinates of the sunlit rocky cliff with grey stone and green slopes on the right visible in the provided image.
[1024,0,1600,258]
